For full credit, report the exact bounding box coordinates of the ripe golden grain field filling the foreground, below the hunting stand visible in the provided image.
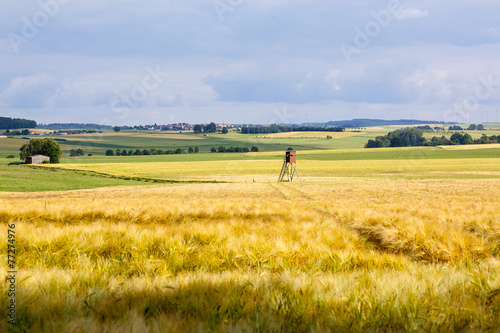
[0,165,500,332]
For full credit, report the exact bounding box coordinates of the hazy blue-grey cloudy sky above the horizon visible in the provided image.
[0,0,500,125]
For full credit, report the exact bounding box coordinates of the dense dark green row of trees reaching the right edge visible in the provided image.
[365,128,500,148]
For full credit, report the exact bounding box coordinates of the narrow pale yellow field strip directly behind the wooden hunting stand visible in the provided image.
[44,156,500,184]
